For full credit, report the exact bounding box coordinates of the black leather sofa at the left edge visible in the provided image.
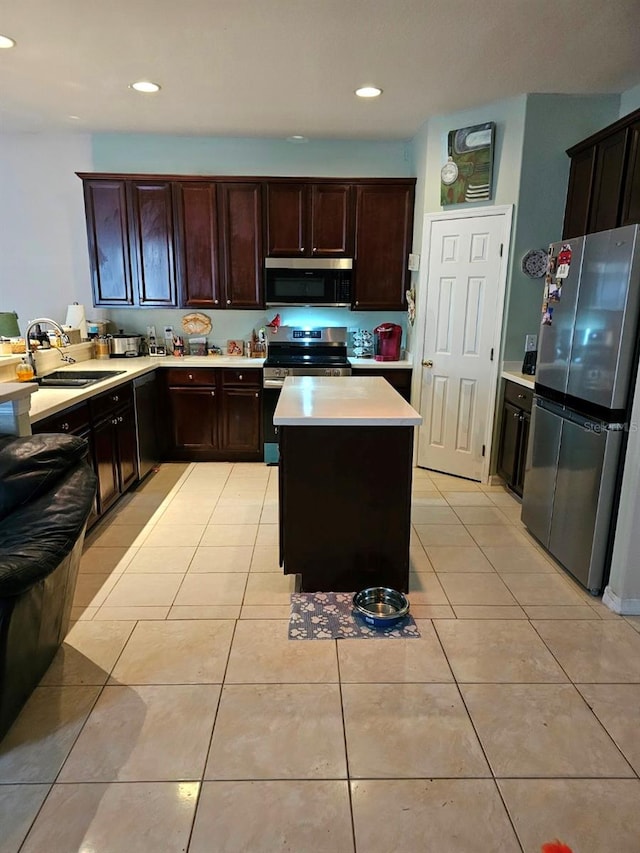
[0,434,96,738]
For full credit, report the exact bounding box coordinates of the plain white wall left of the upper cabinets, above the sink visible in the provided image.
[0,133,95,332]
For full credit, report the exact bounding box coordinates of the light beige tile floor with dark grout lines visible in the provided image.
[0,463,640,853]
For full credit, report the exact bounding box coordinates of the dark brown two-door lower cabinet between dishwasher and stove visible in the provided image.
[166,367,262,462]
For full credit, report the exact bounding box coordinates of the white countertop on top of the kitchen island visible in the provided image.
[273,376,422,426]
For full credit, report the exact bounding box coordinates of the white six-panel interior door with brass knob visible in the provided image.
[418,212,510,480]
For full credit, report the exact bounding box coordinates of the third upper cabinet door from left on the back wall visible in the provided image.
[173,181,224,308]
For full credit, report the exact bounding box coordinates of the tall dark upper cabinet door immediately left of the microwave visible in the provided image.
[219,181,264,308]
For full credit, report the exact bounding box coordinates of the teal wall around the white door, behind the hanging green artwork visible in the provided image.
[412,94,620,361]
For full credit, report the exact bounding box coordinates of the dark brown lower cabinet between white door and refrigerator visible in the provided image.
[498,382,533,497]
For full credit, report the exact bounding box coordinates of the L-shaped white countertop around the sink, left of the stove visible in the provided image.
[19,355,264,423]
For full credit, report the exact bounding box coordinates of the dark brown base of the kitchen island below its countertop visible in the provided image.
[279,426,413,592]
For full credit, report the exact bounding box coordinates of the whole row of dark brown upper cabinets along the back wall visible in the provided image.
[78,173,415,310]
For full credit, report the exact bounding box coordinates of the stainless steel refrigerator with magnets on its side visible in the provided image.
[522,225,640,594]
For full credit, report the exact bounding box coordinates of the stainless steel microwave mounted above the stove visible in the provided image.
[265,258,353,308]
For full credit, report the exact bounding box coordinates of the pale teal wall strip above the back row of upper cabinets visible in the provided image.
[93,134,412,178]
